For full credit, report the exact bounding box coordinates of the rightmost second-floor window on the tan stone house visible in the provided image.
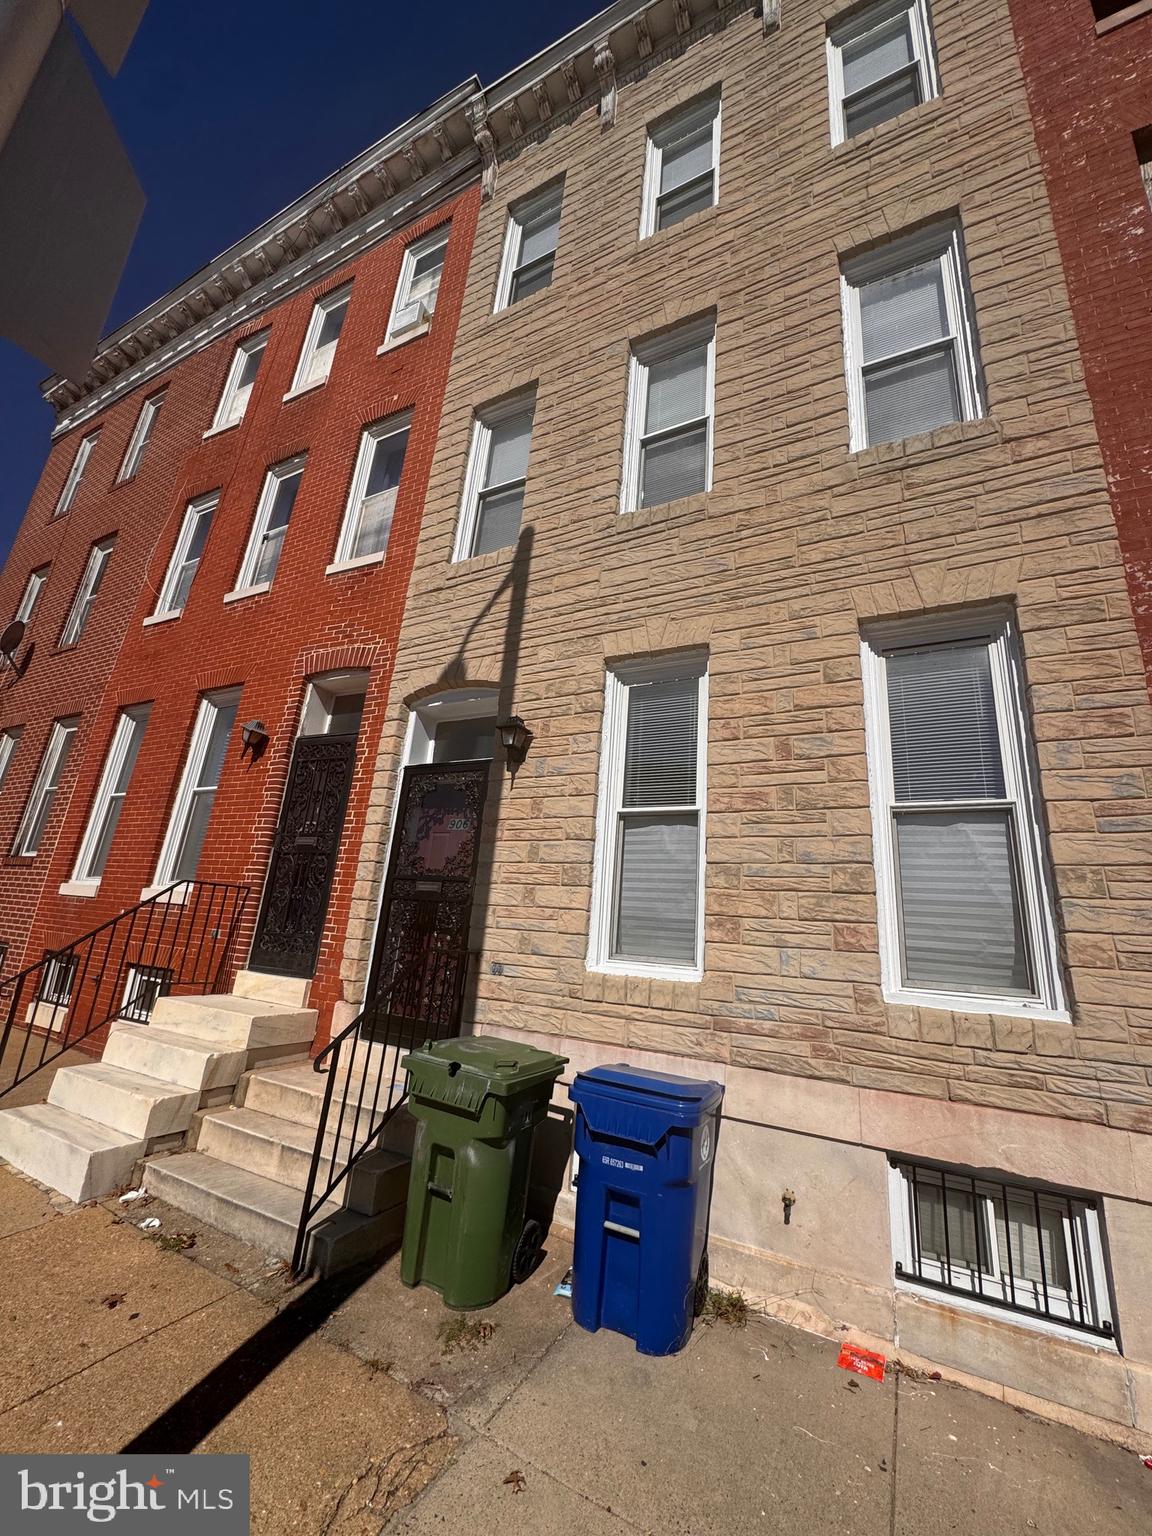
[843,224,985,450]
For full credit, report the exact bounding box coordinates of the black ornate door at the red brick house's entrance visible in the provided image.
[249,736,356,975]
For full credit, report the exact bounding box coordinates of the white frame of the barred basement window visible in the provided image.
[888,1158,1117,1353]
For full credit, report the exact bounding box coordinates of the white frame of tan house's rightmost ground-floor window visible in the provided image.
[860,608,1071,1023]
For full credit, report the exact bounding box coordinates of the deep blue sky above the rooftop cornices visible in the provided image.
[0,0,595,558]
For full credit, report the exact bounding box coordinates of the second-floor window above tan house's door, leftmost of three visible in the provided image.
[453,396,536,561]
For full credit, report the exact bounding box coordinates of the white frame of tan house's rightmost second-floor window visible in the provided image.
[840,220,986,453]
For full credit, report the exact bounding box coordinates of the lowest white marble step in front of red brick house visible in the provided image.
[0,1105,146,1203]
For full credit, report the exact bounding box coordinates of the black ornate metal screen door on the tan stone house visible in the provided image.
[369,762,488,1037]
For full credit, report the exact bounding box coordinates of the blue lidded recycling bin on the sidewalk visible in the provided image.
[568,1066,723,1355]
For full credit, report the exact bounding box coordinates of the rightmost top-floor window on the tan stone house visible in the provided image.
[828,0,940,144]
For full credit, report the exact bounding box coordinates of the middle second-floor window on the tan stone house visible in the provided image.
[621,319,716,511]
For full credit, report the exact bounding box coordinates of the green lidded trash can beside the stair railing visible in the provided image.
[399,1035,567,1312]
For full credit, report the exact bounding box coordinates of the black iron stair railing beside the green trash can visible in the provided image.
[292,935,468,1275]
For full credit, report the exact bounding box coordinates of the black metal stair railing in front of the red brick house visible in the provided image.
[0,880,249,1098]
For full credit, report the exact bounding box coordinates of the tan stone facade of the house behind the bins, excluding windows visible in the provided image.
[344,0,1152,1428]
